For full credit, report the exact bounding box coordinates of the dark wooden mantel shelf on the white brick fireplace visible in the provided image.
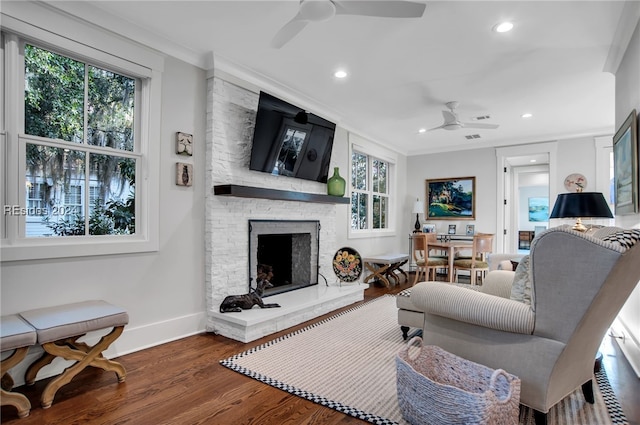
[213,184,350,204]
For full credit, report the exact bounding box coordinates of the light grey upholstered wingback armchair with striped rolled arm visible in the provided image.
[410,227,640,424]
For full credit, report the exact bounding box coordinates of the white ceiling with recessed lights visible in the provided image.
[50,0,624,155]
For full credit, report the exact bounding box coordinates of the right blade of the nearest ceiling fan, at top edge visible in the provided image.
[333,0,427,18]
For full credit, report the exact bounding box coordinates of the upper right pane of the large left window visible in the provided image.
[87,66,135,151]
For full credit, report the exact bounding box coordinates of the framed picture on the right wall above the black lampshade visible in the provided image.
[613,109,638,215]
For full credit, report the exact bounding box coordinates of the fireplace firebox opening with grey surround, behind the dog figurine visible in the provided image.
[249,220,320,297]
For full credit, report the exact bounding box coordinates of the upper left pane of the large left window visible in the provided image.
[24,45,84,143]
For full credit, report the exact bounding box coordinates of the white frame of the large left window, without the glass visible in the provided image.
[0,11,164,262]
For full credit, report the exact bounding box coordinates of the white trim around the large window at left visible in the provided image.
[0,3,164,262]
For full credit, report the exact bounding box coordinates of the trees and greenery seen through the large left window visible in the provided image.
[21,44,140,237]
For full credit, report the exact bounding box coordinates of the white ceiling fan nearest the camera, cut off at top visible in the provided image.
[271,0,426,49]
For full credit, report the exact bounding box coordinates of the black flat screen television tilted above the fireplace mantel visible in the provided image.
[249,92,336,183]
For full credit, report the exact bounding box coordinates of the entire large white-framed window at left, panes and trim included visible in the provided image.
[0,12,163,261]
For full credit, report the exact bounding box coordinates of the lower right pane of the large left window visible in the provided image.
[89,154,136,235]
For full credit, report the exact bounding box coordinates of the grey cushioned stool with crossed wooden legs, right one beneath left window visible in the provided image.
[20,301,129,409]
